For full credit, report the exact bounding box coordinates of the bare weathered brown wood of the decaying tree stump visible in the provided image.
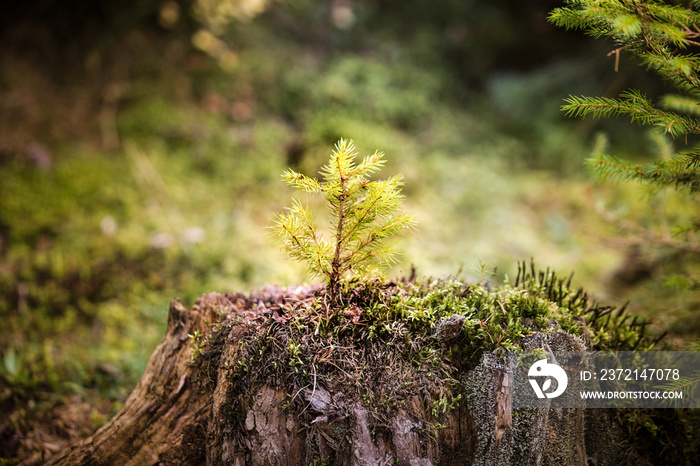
[23,287,614,466]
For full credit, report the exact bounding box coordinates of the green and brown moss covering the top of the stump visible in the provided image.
[195,265,653,460]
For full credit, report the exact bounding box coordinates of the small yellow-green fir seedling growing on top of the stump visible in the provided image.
[272,139,413,305]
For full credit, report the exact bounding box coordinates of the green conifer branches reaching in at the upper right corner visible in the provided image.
[549,0,700,270]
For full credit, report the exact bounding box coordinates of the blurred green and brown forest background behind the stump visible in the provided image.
[0,0,700,461]
